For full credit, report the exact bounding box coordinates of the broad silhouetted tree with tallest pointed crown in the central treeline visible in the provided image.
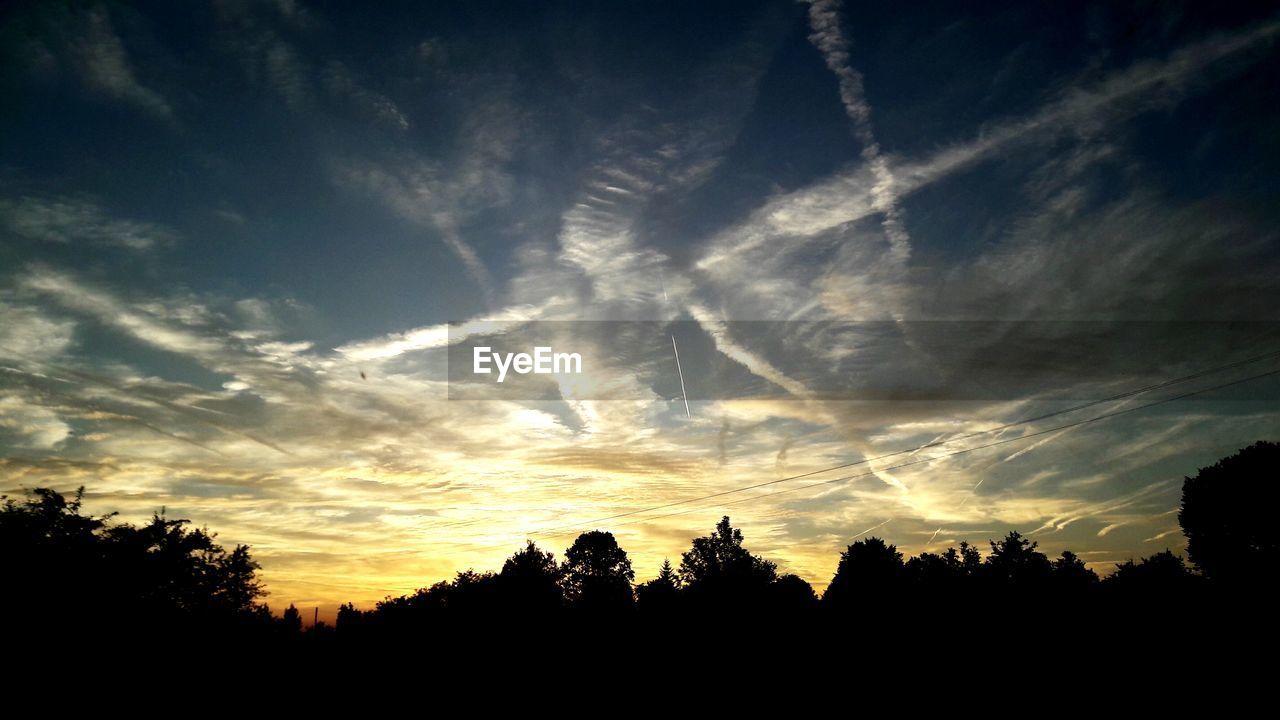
[680,515,777,601]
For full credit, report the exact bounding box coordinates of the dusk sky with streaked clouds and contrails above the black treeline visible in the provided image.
[0,0,1280,614]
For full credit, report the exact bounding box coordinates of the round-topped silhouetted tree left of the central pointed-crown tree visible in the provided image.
[561,530,636,610]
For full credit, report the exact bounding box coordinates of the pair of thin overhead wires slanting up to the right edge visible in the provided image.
[530,351,1280,536]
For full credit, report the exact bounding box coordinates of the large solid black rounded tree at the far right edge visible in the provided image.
[1178,442,1280,583]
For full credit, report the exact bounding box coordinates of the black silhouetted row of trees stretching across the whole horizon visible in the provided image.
[0,442,1280,638]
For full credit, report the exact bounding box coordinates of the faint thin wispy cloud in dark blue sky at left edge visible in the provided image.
[0,197,178,250]
